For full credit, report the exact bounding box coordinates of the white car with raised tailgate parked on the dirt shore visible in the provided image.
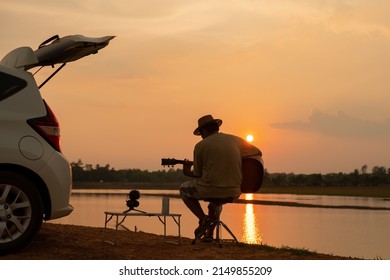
[0,35,114,254]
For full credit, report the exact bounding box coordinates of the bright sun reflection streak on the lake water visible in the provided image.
[242,194,262,244]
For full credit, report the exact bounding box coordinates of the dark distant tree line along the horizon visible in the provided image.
[71,160,390,186]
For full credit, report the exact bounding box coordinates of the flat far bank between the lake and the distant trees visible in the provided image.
[73,182,390,199]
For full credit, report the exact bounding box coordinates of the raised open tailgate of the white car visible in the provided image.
[1,35,115,88]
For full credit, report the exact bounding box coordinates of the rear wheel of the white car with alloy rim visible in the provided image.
[0,171,43,254]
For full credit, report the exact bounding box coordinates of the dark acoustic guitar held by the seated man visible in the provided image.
[161,157,264,193]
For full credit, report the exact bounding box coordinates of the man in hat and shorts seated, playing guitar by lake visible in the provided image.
[173,115,262,240]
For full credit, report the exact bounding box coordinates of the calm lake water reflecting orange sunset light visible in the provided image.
[52,190,390,260]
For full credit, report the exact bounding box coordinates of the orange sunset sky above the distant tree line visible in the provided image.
[0,0,390,173]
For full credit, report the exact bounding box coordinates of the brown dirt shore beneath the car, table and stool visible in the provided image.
[0,223,354,260]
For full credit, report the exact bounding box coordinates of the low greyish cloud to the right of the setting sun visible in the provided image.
[271,110,390,139]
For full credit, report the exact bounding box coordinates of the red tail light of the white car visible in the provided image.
[27,101,61,152]
